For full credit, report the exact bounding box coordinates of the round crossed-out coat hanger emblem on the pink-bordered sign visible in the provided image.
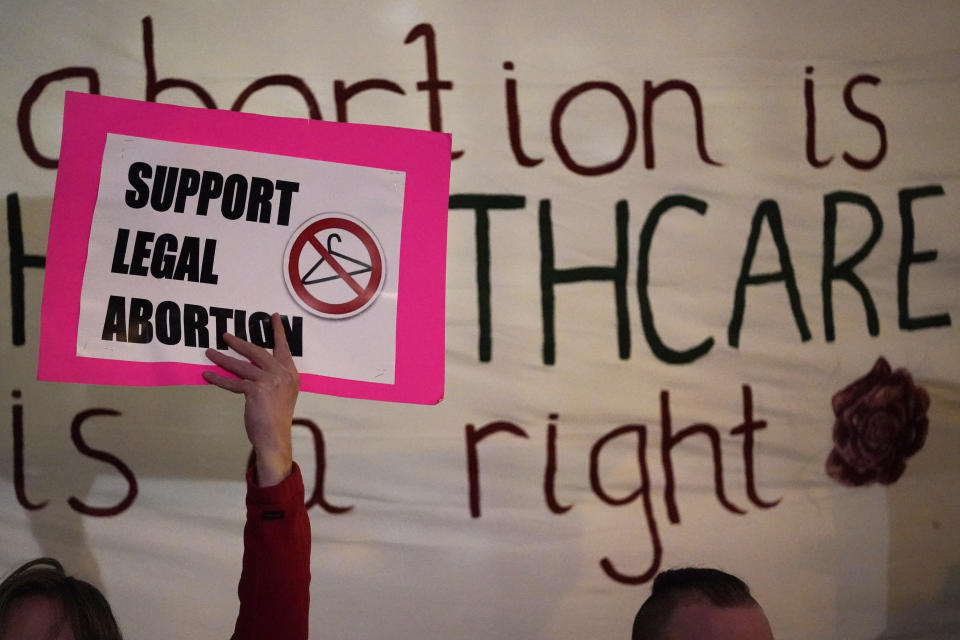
[283,213,386,318]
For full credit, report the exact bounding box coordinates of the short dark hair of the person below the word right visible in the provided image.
[632,567,759,640]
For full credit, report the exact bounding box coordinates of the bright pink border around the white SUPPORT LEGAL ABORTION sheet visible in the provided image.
[37,92,451,404]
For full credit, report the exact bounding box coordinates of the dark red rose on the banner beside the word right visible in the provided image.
[826,357,930,486]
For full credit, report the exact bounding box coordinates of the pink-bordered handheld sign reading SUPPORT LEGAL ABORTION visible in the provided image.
[38,93,450,403]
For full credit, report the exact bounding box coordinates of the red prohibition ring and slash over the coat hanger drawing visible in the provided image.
[287,217,383,316]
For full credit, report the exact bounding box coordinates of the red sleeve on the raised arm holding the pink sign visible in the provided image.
[232,464,311,640]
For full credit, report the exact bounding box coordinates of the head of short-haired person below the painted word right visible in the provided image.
[632,567,773,640]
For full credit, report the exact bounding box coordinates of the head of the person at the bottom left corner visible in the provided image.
[0,558,123,640]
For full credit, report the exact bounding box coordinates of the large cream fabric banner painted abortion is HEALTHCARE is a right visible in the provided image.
[0,1,960,639]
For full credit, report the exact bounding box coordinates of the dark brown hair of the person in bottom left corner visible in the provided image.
[0,558,123,640]
